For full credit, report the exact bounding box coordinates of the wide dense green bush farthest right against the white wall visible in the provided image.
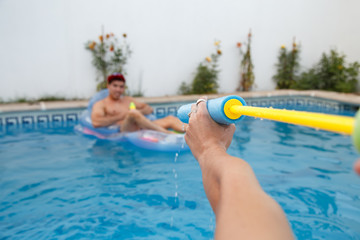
[295,49,360,92]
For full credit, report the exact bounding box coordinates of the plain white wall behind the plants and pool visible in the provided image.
[0,0,360,100]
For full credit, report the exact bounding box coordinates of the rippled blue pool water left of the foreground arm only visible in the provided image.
[0,129,213,239]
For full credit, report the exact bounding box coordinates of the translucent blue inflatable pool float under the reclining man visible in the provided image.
[75,89,189,152]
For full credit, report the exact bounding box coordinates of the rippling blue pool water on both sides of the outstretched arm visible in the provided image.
[0,109,360,239]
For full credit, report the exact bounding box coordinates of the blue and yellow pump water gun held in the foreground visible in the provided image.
[177,95,360,152]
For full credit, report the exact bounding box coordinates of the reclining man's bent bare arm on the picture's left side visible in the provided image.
[91,101,121,128]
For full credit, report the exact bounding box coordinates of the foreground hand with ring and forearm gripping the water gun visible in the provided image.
[185,102,293,240]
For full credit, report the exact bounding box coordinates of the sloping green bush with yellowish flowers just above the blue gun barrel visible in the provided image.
[178,41,222,94]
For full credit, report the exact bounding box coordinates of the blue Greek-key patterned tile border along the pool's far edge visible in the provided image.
[0,96,359,128]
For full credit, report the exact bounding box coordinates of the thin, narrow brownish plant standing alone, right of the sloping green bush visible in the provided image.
[236,31,255,91]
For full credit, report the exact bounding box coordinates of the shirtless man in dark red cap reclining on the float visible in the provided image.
[91,73,184,133]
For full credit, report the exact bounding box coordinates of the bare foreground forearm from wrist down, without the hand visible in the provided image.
[199,149,293,239]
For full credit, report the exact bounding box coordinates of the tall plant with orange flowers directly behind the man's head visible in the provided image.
[85,33,131,90]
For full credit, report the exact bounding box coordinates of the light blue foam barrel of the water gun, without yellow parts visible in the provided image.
[177,95,246,125]
